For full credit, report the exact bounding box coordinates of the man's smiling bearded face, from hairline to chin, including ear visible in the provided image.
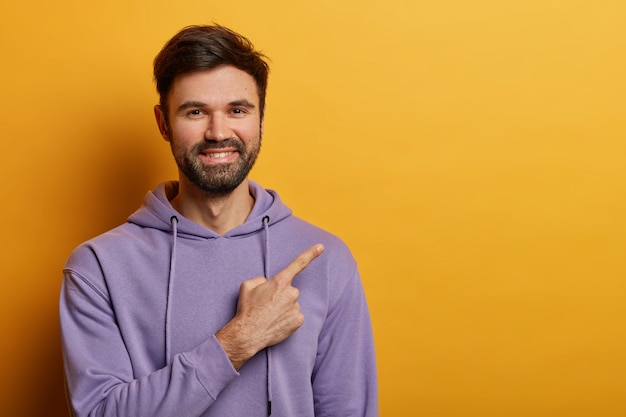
[156,66,262,195]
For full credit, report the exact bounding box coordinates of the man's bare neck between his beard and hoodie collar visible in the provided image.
[171,179,254,235]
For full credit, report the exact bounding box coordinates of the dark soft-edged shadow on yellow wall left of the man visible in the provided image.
[24,102,163,417]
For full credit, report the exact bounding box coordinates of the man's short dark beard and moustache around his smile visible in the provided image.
[170,135,261,196]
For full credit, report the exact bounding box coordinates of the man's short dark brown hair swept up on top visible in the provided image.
[154,25,269,120]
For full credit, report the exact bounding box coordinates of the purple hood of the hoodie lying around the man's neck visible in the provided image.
[128,181,291,239]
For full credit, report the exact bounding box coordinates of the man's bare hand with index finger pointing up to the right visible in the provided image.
[215,244,324,371]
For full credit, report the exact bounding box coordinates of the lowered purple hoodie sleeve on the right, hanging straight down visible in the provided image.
[312,264,378,417]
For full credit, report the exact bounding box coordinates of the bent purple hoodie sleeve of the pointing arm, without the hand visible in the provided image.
[60,269,238,417]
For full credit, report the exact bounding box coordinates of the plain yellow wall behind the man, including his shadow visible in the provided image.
[0,0,626,417]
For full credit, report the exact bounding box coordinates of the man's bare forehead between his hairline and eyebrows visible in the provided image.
[168,66,259,107]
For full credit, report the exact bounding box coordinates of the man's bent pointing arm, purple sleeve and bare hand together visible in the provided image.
[60,245,323,417]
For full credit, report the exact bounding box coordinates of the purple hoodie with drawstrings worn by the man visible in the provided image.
[60,182,378,417]
